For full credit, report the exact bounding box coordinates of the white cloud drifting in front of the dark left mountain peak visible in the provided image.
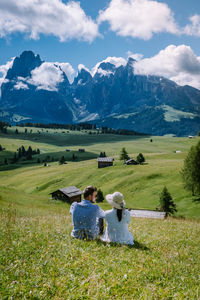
[27,62,74,91]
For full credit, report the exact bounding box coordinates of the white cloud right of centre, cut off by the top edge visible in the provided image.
[98,0,180,40]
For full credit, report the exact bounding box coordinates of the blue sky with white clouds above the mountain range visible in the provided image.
[0,0,200,89]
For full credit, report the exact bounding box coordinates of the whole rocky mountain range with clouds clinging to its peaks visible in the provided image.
[0,51,200,136]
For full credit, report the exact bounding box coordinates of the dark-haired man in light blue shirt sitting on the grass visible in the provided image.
[70,186,105,240]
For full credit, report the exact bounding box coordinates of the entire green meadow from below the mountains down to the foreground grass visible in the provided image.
[0,127,200,299]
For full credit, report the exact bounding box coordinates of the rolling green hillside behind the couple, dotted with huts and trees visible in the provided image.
[0,127,200,218]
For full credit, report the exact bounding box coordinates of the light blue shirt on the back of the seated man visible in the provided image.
[70,200,104,239]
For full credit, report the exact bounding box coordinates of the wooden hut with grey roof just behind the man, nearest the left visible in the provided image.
[50,186,82,203]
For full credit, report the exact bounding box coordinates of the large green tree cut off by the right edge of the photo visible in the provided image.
[181,141,200,196]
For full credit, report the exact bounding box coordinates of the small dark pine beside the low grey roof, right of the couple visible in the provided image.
[159,186,177,215]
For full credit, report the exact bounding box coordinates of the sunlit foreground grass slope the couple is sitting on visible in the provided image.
[0,207,200,299]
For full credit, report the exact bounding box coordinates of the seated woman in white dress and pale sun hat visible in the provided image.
[101,192,134,245]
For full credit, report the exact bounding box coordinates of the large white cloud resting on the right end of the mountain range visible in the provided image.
[134,45,200,89]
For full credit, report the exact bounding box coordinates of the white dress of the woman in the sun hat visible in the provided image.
[101,208,134,245]
